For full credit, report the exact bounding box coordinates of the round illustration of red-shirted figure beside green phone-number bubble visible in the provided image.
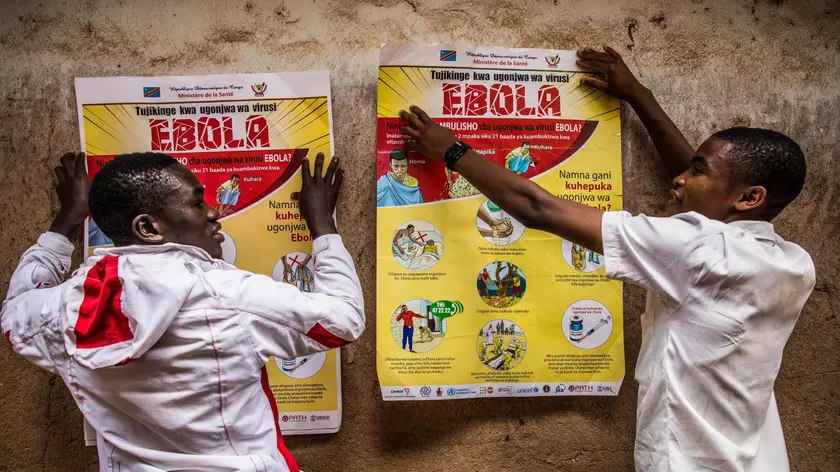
[391,298,446,354]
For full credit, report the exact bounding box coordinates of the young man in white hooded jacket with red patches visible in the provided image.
[0,153,365,472]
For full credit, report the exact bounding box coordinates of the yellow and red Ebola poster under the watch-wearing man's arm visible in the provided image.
[376,44,624,400]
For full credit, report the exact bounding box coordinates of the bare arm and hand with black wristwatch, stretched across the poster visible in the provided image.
[400,107,603,253]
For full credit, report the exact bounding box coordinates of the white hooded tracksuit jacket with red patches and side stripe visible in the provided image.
[0,233,365,472]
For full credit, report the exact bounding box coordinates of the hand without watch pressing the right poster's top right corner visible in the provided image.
[577,46,647,102]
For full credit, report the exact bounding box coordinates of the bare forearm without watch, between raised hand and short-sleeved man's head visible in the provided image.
[629,88,694,178]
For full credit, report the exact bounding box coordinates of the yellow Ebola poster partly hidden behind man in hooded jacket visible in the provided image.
[76,72,341,434]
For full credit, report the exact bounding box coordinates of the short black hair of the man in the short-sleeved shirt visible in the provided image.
[713,127,805,221]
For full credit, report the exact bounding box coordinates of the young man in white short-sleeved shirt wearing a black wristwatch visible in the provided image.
[401,48,814,472]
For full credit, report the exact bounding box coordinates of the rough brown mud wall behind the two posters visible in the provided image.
[0,0,840,472]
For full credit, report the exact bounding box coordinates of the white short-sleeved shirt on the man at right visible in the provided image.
[602,212,815,472]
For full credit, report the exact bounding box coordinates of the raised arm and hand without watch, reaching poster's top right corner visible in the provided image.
[577,46,694,178]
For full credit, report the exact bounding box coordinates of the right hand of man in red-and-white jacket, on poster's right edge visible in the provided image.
[292,152,344,240]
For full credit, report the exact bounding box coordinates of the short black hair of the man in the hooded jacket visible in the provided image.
[88,152,178,246]
